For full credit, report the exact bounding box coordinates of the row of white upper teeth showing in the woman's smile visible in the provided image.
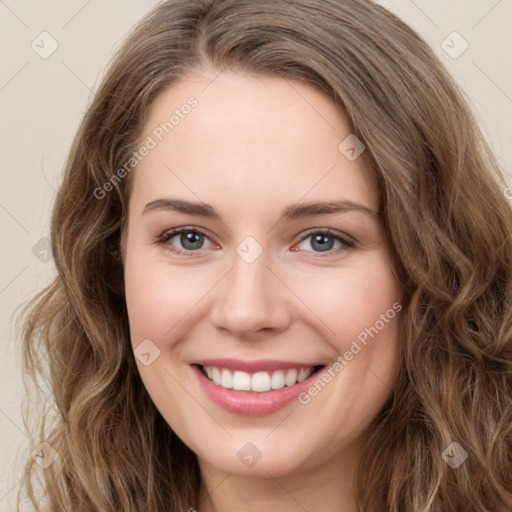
[203,366,314,393]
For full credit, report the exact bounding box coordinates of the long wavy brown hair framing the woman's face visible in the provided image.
[18,0,512,512]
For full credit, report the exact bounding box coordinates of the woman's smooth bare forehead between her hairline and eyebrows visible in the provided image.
[128,71,377,214]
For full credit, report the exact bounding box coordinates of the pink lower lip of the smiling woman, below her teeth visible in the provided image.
[192,365,321,416]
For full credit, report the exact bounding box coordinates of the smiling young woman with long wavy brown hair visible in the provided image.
[16,0,512,512]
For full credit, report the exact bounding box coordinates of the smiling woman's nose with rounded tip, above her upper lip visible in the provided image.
[211,251,293,340]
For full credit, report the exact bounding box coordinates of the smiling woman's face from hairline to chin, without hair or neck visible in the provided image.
[125,71,401,477]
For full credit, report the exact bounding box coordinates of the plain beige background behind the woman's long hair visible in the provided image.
[0,0,512,511]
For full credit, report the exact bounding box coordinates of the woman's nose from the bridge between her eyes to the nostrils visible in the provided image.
[212,237,289,336]
